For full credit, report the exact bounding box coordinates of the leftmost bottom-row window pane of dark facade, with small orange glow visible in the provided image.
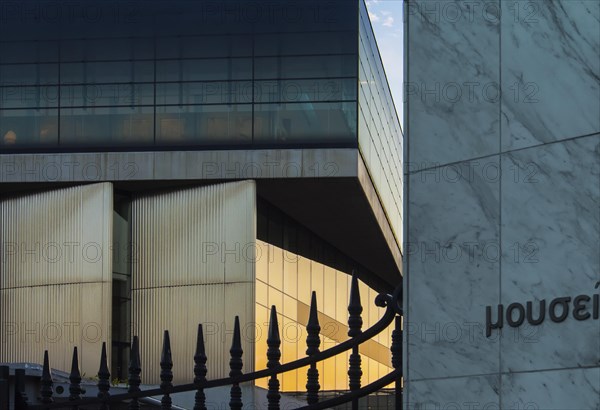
[0,109,58,148]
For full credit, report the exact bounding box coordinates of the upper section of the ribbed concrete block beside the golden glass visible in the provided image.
[132,182,256,289]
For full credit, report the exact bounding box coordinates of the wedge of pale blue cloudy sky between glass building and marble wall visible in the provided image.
[366,0,404,125]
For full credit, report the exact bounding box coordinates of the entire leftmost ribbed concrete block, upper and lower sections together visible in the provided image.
[0,183,113,374]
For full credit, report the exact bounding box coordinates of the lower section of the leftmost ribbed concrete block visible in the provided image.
[0,282,111,375]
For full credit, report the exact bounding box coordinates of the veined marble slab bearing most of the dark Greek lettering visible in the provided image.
[501,134,600,371]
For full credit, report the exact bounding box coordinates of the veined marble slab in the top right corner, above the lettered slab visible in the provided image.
[501,0,600,150]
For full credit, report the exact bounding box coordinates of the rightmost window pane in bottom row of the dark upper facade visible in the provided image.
[254,102,356,143]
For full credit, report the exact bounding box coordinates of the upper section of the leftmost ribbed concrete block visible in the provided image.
[0,183,112,289]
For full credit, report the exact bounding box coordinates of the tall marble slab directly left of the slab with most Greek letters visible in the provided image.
[404,157,500,380]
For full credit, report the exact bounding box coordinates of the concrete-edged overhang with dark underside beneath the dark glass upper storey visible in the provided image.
[0,148,402,291]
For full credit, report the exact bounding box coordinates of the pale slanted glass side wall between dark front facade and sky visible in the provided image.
[358,1,403,246]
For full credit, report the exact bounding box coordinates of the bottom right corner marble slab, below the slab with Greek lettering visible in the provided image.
[501,368,600,410]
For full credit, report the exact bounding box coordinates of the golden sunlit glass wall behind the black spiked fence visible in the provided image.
[255,204,393,392]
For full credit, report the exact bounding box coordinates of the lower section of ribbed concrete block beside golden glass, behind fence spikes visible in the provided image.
[132,283,255,383]
